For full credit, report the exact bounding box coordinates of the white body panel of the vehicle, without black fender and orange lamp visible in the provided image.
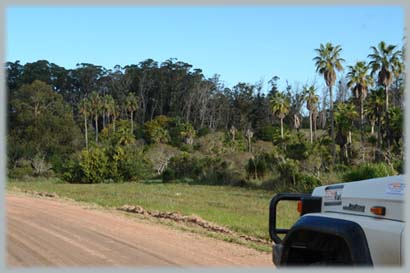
[310,176,405,265]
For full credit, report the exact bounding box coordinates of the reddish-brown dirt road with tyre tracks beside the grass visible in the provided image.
[6,194,272,267]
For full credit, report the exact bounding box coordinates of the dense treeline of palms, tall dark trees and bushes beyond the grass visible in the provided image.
[6,42,404,190]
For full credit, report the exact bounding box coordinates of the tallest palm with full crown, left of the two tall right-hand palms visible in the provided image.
[313,43,344,160]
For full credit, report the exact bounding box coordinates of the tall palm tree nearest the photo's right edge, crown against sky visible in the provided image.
[368,41,404,150]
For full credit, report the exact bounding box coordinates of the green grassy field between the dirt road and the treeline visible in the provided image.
[7,179,297,239]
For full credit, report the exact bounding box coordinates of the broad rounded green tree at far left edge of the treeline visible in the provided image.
[7,80,81,166]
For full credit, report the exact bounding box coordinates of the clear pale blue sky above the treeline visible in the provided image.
[6,6,404,91]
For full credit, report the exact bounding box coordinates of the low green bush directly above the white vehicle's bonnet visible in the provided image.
[343,163,396,181]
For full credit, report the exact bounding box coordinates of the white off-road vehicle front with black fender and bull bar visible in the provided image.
[269,175,405,266]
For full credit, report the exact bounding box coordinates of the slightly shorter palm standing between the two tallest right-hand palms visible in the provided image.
[347,61,373,160]
